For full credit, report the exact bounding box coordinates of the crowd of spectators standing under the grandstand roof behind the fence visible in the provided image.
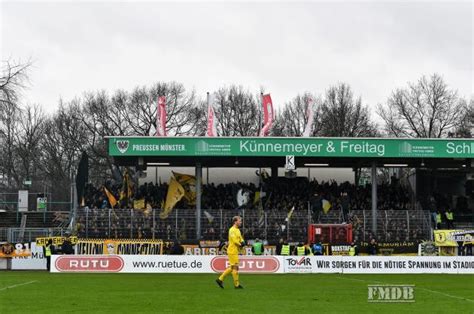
[77,178,430,241]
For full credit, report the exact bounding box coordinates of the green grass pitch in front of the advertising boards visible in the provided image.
[0,271,474,314]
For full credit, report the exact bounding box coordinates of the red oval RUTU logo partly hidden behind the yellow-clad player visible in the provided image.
[211,256,282,273]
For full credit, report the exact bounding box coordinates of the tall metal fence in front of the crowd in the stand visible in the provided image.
[73,208,431,242]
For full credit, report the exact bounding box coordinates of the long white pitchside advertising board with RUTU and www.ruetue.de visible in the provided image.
[51,255,474,274]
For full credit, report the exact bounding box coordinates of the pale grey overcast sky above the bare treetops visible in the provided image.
[0,1,474,116]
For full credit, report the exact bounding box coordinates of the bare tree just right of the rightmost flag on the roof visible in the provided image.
[317,83,377,137]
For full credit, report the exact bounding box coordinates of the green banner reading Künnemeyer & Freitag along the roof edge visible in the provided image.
[107,136,474,158]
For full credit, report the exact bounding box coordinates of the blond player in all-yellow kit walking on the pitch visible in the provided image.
[216,216,245,289]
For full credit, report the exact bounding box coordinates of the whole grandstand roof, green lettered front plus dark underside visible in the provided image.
[106,136,474,169]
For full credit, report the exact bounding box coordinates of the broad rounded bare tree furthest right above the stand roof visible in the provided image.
[378,74,466,138]
